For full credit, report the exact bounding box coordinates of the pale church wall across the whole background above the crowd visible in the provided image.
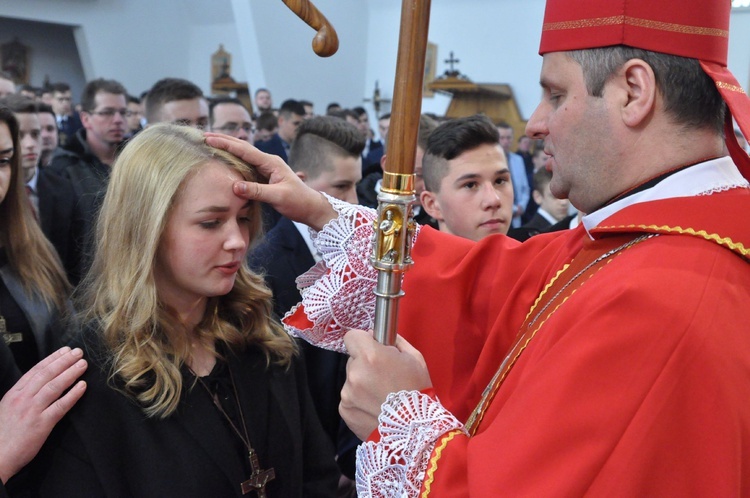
[0,0,750,130]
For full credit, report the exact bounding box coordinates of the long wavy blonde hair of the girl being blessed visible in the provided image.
[82,124,295,418]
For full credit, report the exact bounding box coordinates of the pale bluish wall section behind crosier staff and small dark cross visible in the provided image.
[367,0,544,122]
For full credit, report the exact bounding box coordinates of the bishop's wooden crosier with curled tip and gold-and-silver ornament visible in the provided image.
[283,0,430,344]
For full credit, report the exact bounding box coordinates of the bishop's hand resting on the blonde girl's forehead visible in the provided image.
[205,133,336,230]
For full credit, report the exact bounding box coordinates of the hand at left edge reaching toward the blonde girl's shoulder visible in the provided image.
[0,347,88,483]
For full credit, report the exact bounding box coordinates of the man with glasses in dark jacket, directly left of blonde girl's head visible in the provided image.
[38,78,129,285]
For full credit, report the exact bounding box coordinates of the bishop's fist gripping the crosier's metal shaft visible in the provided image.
[339,330,432,440]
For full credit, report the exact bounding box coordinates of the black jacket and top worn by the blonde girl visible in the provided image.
[28,324,339,498]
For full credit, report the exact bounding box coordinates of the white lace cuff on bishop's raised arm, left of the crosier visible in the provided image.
[282,196,419,353]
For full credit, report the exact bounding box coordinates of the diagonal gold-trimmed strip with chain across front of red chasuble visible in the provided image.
[466,234,658,436]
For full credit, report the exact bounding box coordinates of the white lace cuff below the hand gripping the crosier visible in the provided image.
[356,391,468,498]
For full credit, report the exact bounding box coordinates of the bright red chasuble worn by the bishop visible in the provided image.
[399,189,750,497]
